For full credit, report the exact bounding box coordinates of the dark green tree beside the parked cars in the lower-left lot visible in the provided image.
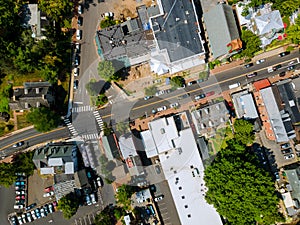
[58,193,79,219]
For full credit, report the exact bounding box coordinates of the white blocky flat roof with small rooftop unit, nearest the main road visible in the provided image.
[149,117,178,153]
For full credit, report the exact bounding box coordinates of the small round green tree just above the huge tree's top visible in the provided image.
[233,119,254,145]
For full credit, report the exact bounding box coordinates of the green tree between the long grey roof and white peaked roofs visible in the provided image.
[242,30,261,58]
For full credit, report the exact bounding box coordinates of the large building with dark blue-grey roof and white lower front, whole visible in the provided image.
[149,0,205,74]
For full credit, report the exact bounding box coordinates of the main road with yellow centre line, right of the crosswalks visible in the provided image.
[99,51,300,124]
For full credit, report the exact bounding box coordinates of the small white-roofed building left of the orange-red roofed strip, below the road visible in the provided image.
[231,90,258,119]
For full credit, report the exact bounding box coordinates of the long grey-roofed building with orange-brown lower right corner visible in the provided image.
[203,4,242,59]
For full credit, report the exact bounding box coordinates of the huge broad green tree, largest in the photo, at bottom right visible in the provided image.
[204,139,282,225]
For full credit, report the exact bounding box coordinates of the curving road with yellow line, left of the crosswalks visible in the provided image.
[0,127,70,156]
